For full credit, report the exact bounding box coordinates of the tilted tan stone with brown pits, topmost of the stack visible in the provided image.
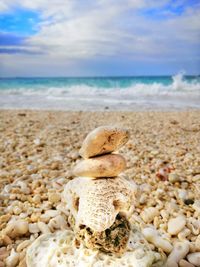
[79,126,129,158]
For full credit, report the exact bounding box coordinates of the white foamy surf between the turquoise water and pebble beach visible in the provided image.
[0,73,200,110]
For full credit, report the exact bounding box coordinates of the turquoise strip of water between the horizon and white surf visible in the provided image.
[0,76,200,90]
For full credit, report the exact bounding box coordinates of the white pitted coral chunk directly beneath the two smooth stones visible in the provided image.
[63,177,136,232]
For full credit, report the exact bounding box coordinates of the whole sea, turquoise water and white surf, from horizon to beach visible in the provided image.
[0,73,200,111]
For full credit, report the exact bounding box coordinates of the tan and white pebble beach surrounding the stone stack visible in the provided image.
[0,110,200,267]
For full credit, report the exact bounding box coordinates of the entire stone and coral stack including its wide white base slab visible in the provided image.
[26,126,159,267]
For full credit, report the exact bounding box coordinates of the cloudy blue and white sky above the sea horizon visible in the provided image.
[0,0,200,77]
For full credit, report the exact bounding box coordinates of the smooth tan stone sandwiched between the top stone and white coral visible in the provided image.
[72,154,126,177]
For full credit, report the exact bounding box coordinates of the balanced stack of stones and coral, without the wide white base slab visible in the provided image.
[63,126,135,253]
